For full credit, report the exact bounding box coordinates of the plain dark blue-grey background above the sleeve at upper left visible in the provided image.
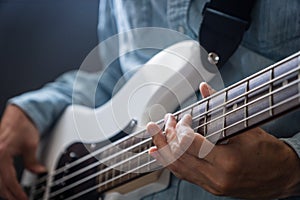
[0,0,99,178]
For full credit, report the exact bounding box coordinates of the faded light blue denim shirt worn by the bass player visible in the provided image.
[9,0,300,199]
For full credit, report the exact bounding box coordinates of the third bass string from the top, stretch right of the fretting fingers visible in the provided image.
[192,79,300,134]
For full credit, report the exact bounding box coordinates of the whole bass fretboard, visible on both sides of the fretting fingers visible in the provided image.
[99,52,300,193]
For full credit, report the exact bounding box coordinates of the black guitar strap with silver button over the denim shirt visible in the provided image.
[199,0,256,67]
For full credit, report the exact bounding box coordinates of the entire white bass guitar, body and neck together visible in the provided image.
[23,41,300,200]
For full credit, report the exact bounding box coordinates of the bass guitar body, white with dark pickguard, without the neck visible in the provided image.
[23,41,220,199]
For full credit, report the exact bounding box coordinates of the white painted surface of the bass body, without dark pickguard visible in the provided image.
[23,41,219,199]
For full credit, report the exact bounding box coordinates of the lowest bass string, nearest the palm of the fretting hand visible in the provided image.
[41,91,300,200]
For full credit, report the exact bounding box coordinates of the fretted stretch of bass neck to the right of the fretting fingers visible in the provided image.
[175,52,300,143]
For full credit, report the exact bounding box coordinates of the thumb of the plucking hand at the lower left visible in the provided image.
[23,149,47,174]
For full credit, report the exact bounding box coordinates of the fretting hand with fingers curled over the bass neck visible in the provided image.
[147,84,300,199]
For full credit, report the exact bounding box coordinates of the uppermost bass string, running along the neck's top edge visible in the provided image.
[32,52,299,188]
